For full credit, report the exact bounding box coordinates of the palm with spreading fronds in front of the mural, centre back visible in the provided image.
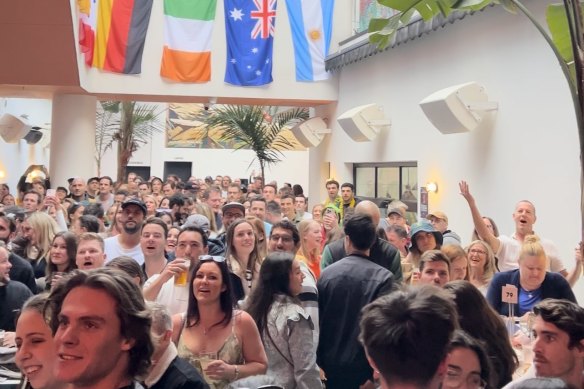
[200,105,308,179]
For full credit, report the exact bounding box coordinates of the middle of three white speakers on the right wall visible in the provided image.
[337,104,391,142]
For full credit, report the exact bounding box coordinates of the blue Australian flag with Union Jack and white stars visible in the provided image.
[224,0,276,86]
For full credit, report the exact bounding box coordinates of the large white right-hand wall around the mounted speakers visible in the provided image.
[322,1,580,267]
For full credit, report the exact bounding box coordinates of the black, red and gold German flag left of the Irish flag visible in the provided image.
[92,0,153,74]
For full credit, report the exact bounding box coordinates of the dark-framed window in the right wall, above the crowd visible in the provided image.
[353,162,418,216]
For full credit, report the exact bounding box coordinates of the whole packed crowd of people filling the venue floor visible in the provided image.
[0,172,584,389]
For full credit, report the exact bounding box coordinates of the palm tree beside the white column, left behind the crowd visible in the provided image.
[95,101,164,184]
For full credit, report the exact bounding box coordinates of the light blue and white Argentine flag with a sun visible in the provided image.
[286,0,335,81]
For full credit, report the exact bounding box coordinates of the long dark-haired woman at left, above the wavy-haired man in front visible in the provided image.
[45,231,77,290]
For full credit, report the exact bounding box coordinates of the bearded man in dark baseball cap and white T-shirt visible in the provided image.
[104,198,146,265]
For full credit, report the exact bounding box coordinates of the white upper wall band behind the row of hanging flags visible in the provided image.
[71,0,353,101]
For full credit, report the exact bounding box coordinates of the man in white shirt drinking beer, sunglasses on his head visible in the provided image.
[143,225,209,315]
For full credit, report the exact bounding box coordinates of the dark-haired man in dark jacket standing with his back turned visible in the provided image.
[317,214,394,389]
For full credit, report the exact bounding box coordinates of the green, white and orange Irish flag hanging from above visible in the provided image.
[160,0,217,82]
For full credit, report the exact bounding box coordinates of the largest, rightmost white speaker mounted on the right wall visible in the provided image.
[420,82,497,134]
